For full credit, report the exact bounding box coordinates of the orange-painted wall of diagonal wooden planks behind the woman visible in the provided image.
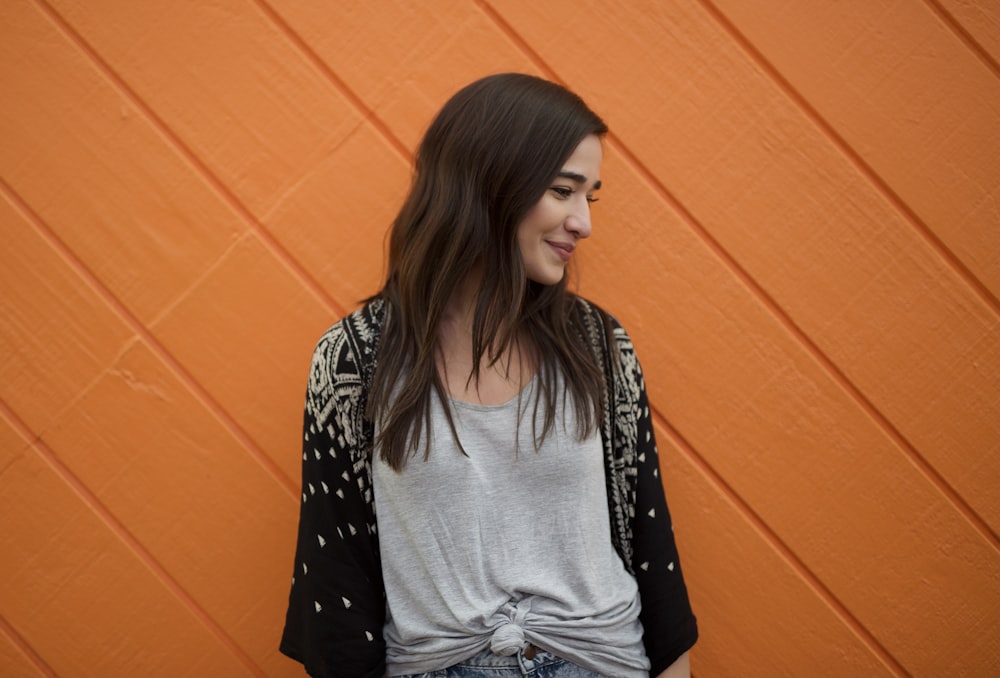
[0,0,1000,678]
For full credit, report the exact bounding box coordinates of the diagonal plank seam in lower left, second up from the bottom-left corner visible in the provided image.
[0,401,266,678]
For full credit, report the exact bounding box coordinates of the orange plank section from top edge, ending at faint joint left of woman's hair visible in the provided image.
[45,0,357,216]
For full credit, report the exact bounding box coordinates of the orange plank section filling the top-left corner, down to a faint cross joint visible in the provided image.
[0,2,244,320]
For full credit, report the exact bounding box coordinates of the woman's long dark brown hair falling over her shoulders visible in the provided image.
[367,73,607,471]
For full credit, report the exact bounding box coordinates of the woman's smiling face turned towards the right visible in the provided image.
[517,134,603,285]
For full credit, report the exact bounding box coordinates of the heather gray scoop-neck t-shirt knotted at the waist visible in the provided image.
[373,377,649,676]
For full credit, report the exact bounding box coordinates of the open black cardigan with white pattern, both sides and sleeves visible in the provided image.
[280,299,698,678]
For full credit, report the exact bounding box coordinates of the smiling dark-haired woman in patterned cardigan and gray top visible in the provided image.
[281,74,697,678]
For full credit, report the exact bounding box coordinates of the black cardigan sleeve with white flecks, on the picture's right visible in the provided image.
[615,326,698,676]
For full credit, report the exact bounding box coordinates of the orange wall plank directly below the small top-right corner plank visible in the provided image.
[715,0,1000,301]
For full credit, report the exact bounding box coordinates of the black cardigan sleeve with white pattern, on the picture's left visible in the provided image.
[280,323,385,677]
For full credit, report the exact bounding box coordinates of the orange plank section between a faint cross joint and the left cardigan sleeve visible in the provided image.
[152,235,334,484]
